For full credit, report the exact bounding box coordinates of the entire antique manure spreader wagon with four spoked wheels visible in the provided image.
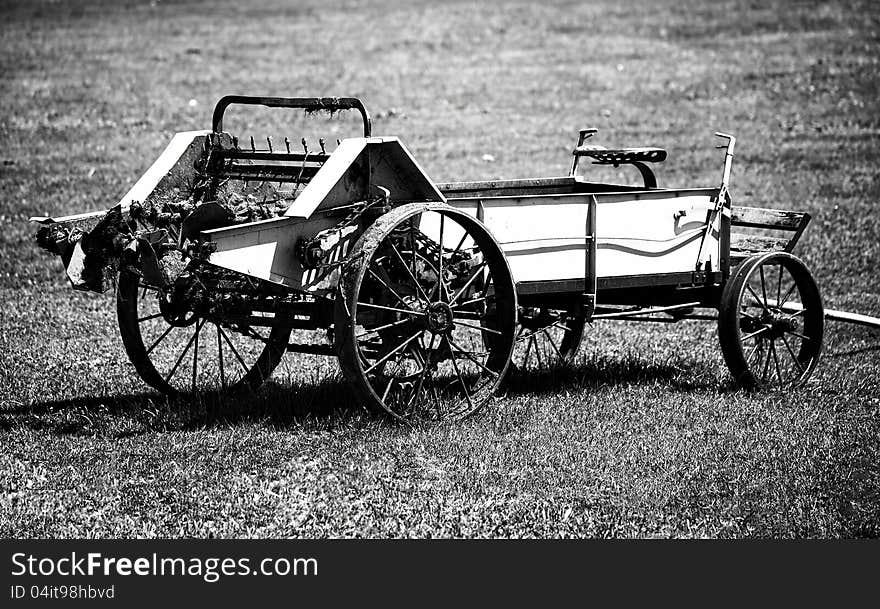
[34,96,823,421]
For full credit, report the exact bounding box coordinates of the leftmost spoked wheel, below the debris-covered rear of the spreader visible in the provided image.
[116,271,291,395]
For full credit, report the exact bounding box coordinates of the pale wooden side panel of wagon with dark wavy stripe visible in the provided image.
[444,188,722,293]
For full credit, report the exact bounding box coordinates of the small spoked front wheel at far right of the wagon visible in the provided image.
[718,252,825,388]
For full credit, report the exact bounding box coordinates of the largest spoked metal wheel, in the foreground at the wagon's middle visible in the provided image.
[335,203,516,422]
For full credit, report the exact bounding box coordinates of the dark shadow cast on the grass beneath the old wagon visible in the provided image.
[0,358,716,438]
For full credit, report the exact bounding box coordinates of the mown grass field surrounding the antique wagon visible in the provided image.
[0,0,880,537]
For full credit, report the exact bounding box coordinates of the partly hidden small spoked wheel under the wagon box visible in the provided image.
[511,307,585,373]
